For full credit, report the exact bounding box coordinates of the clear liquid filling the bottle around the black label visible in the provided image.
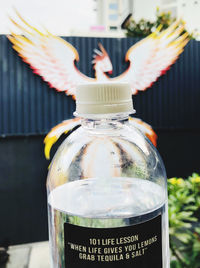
[48,178,169,268]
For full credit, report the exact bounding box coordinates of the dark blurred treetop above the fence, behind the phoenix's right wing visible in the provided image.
[124,8,193,38]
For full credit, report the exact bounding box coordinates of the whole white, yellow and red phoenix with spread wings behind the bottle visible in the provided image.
[8,11,190,159]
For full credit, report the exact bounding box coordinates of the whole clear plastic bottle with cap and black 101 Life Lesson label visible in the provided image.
[47,83,169,268]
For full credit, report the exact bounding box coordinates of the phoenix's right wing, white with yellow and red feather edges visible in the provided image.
[112,21,190,94]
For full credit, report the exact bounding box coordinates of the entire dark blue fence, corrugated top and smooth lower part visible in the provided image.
[0,36,200,245]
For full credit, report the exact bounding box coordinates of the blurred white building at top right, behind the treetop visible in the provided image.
[93,0,200,36]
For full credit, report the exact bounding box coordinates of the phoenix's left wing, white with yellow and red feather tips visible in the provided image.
[8,13,94,95]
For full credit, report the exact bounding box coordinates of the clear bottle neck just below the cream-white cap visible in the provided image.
[81,113,129,130]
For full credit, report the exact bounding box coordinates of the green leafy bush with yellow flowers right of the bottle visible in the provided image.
[168,173,200,268]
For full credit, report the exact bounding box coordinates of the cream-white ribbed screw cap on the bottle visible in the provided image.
[75,82,135,116]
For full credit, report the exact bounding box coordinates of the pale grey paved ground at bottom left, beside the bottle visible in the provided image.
[0,242,50,268]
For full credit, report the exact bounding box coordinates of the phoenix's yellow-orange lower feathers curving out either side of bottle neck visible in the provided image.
[44,117,157,159]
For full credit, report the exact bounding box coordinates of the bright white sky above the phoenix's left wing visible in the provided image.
[0,0,96,35]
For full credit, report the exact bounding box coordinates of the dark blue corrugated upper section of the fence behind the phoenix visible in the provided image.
[0,36,200,136]
